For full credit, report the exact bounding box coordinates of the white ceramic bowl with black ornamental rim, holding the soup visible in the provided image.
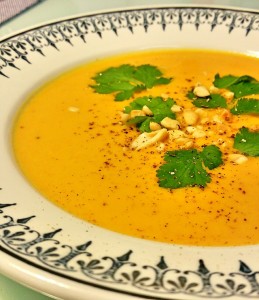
[0,6,259,300]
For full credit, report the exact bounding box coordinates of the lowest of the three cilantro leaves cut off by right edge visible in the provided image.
[234,127,259,156]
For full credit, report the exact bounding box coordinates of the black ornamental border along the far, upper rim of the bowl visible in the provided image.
[0,8,259,77]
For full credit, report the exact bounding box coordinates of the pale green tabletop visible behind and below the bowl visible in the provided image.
[0,0,259,300]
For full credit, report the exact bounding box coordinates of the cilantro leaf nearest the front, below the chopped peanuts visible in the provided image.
[157,145,222,189]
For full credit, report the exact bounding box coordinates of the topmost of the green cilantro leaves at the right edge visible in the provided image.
[213,74,259,98]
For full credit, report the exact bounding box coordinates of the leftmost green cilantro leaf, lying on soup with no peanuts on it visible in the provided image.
[91,64,171,101]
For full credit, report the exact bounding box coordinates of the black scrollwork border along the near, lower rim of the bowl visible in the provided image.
[0,204,259,299]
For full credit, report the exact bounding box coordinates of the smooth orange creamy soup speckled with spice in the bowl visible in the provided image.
[13,50,259,246]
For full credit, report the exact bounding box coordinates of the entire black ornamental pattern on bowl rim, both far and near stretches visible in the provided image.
[0,8,259,299]
